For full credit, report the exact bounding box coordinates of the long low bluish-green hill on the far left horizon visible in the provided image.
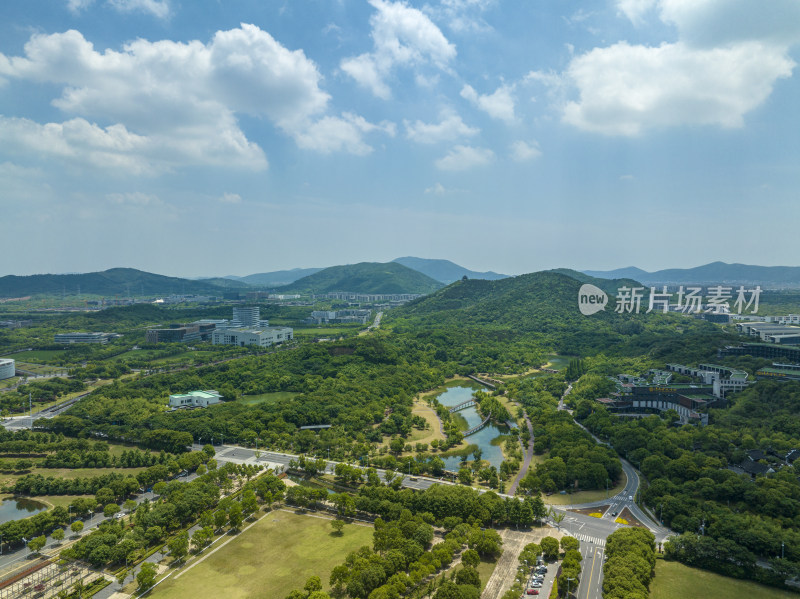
[0,268,236,297]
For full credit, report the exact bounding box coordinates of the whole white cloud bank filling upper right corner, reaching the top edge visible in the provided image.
[563,0,800,136]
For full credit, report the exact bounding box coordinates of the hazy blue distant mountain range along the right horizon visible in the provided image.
[582,262,800,289]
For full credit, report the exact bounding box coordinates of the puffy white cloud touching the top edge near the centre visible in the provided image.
[340,0,456,99]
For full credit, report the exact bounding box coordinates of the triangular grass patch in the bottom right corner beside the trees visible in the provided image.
[650,559,797,599]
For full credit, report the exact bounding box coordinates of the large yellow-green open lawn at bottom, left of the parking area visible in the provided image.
[150,511,372,599]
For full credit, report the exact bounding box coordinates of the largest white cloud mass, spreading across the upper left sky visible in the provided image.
[0,24,386,173]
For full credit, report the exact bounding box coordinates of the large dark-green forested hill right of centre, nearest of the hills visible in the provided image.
[384,271,735,360]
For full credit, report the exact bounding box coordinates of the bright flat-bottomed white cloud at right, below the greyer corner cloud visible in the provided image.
[563,42,794,135]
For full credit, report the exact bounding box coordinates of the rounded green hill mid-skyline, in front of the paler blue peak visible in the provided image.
[278,262,442,293]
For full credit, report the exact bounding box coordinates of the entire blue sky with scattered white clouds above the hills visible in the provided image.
[0,0,800,276]
